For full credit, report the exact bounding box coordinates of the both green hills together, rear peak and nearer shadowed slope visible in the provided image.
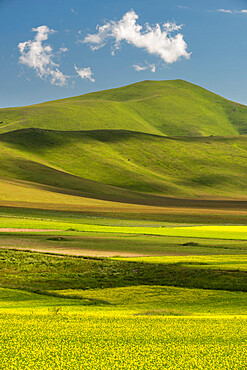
[0,80,247,205]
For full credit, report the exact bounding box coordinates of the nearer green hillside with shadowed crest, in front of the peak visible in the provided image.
[0,129,247,198]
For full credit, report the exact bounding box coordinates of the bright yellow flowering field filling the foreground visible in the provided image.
[0,308,247,370]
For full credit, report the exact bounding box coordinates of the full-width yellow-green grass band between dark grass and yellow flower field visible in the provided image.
[0,285,247,317]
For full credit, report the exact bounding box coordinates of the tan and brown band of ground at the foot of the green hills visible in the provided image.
[0,202,247,226]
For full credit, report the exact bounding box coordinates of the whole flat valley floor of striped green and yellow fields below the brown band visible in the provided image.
[0,207,247,370]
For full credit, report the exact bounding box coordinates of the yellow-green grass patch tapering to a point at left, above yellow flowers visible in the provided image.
[51,286,247,316]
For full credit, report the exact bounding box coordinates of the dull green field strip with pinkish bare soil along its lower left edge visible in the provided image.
[0,232,247,257]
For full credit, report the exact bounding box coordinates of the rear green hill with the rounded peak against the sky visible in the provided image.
[0,80,247,136]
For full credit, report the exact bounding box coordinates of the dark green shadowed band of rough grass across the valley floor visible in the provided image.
[0,250,247,293]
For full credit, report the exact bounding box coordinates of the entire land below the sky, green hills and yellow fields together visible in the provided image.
[0,80,247,370]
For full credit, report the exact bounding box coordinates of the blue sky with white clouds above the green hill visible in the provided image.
[0,0,247,107]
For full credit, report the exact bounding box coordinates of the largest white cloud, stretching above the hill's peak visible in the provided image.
[82,10,190,63]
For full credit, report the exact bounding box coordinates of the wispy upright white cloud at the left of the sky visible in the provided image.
[18,26,67,86]
